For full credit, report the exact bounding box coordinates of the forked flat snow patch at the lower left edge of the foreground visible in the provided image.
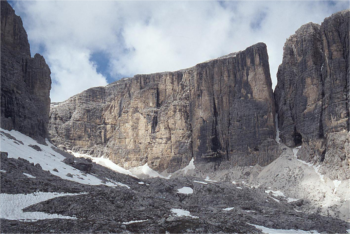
[0,192,86,222]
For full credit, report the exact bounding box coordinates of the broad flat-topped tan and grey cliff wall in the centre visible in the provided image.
[49,43,277,172]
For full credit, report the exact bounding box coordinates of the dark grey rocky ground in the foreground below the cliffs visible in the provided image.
[0,130,350,233]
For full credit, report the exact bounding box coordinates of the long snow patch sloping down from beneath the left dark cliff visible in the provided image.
[0,128,124,186]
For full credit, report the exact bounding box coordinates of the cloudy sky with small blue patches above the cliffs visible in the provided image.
[9,0,350,101]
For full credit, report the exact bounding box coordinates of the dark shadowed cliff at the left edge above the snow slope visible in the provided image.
[0,0,51,140]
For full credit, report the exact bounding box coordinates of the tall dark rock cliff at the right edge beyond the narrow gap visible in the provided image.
[275,10,350,178]
